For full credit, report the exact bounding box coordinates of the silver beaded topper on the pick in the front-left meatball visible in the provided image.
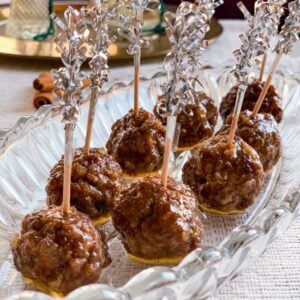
[51,7,87,125]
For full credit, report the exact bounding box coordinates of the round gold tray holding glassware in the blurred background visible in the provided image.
[0,7,223,60]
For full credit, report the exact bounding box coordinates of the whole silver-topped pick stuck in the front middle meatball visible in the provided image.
[159,1,221,187]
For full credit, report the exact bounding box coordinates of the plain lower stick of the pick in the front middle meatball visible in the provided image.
[161,116,177,188]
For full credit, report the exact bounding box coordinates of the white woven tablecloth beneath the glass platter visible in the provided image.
[0,21,300,300]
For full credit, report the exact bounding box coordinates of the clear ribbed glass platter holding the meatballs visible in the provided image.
[0,68,300,300]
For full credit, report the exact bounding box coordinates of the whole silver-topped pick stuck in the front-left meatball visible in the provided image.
[51,7,87,213]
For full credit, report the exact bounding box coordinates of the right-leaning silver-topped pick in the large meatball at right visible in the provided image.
[228,0,279,145]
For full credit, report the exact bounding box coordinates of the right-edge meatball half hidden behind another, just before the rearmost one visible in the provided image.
[220,110,281,172]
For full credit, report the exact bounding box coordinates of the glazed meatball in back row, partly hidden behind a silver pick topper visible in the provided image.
[153,93,218,150]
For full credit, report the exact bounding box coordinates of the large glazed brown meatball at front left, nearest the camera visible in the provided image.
[11,206,110,294]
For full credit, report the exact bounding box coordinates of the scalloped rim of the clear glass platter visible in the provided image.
[0,68,300,299]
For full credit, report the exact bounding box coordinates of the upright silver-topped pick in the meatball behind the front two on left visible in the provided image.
[114,0,159,114]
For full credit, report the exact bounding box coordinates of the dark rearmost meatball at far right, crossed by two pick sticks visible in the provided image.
[220,80,283,123]
